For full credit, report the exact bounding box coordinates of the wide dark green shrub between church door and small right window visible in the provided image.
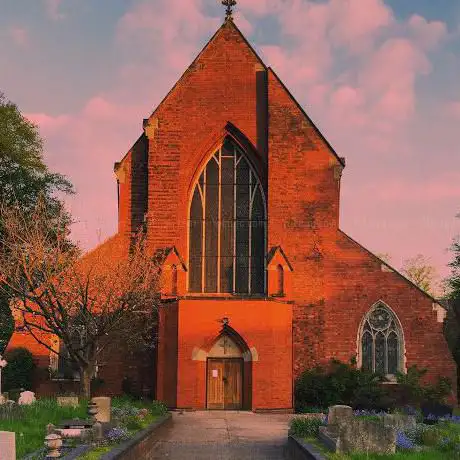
[295,360,385,412]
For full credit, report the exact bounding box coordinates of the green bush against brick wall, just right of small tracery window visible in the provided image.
[396,365,452,405]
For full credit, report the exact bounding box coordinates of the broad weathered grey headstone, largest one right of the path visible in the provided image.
[336,417,396,454]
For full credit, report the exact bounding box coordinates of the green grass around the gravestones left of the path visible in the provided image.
[0,398,168,460]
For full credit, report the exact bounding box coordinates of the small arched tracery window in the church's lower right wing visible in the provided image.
[360,304,404,375]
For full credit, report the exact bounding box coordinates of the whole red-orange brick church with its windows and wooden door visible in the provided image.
[8,11,456,411]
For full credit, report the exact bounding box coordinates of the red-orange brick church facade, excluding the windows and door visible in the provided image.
[11,21,456,410]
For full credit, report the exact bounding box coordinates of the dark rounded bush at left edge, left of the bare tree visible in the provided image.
[2,348,35,391]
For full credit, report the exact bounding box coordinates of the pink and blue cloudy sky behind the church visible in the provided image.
[0,0,460,275]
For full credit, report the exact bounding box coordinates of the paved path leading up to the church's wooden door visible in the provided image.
[147,411,291,460]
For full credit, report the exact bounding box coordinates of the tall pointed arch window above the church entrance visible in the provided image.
[189,138,266,294]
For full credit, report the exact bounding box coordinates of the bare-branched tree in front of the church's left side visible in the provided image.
[0,202,160,397]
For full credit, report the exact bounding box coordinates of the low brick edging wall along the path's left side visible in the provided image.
[101,414,171,460]
